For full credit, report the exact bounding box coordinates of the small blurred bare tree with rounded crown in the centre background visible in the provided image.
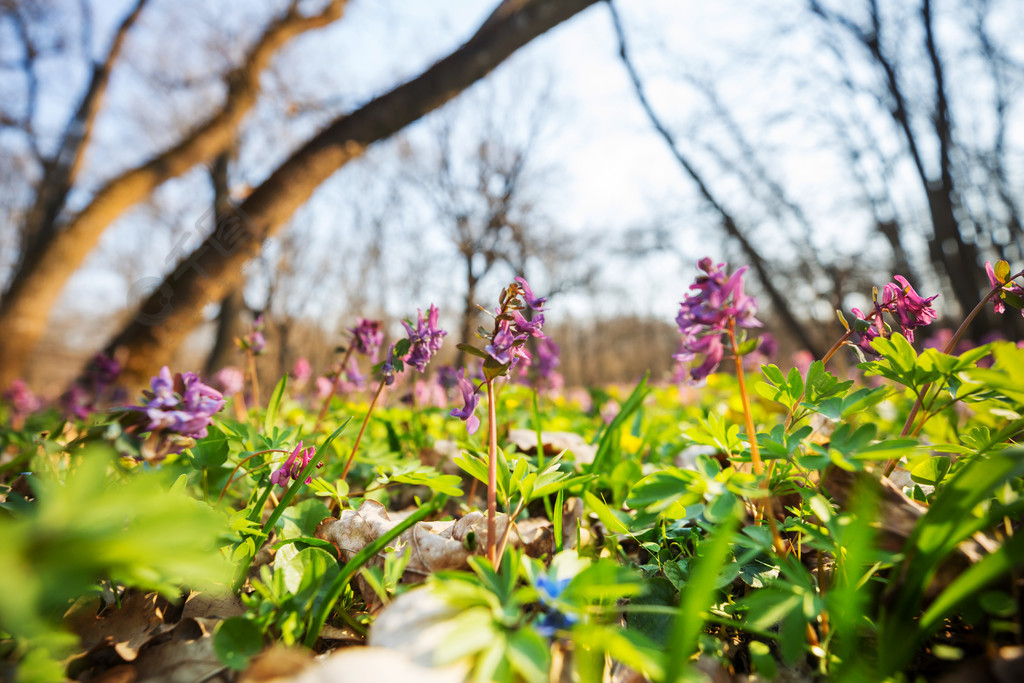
[398,80,599,366]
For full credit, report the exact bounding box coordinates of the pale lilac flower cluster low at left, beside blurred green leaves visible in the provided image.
[129,366,224,438]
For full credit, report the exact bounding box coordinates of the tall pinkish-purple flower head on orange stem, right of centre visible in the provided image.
[673,257,761,381]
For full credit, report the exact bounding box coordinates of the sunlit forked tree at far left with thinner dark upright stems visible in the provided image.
[0,0,345,386]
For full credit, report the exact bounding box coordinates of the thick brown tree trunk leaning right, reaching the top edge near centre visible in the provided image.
[94,0,597,386]
